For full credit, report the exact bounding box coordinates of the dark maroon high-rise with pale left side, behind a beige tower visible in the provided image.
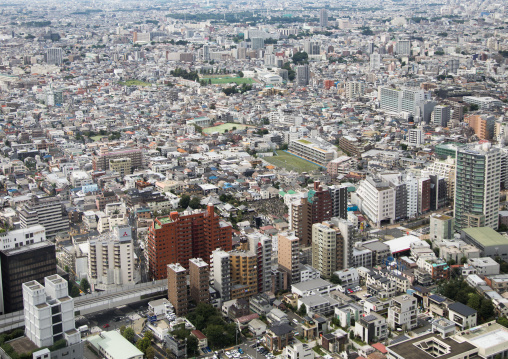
[290,181,332,246]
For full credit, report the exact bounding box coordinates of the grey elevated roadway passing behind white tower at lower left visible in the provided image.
[0,279,168,333]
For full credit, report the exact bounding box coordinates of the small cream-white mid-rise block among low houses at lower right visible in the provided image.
[388,294,418,331]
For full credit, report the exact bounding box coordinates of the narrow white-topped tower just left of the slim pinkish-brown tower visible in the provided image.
[247,233,273,293]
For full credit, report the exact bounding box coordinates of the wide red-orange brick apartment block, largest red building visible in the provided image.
[147,205,232,279]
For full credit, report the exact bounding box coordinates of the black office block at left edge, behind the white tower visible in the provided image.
[0,241,56,314]
